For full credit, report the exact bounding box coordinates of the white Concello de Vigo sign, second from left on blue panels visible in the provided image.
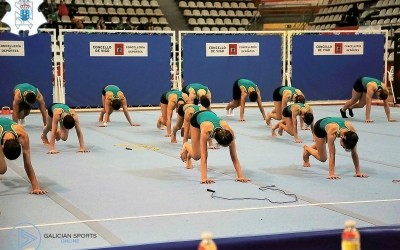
[90,42,148,57]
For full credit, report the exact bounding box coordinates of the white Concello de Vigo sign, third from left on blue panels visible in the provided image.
[206,43,260,57]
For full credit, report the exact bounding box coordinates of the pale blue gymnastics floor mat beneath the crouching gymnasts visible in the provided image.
[0,105,400,250]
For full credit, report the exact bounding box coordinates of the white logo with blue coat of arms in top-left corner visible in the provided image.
[2,0,46,35]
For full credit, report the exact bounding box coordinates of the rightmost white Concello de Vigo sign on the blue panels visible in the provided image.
[314,42,364,56]
